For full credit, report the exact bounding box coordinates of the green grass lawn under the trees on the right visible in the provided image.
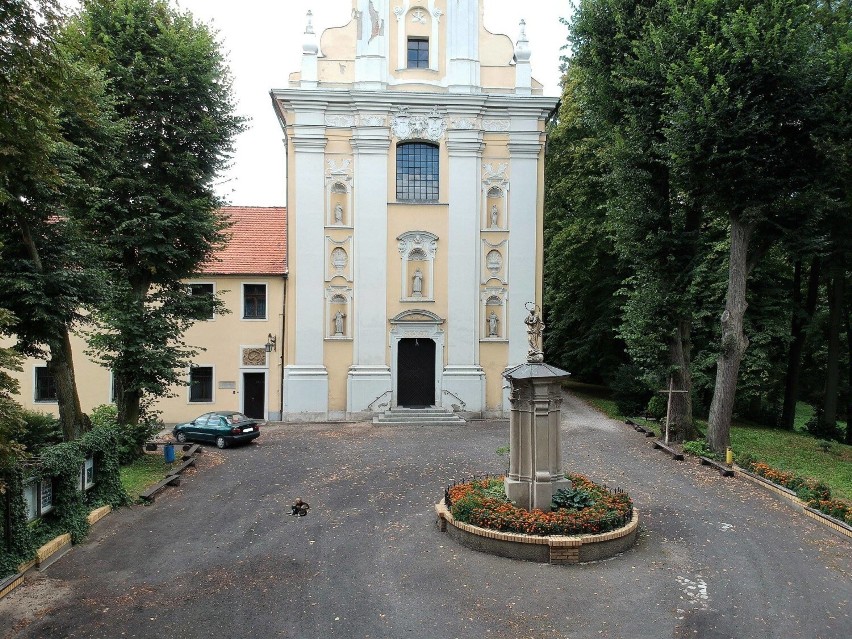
[566,382,852,501]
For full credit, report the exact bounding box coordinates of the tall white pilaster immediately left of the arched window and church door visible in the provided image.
[346,113,391,415]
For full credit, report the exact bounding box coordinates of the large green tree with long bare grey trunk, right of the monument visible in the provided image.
[665,0,822,452]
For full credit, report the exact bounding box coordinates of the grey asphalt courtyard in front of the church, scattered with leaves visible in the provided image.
[0,397,852,639]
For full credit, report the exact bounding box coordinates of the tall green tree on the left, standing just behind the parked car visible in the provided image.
[67,0,243,424]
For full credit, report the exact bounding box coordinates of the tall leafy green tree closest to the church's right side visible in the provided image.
[569,0,702,438]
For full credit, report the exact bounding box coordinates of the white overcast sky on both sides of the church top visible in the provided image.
[68,0,571,206]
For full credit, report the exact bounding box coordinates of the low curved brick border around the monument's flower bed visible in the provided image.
[435,499,639,565]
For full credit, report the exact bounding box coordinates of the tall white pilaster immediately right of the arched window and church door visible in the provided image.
[442,130,485,412]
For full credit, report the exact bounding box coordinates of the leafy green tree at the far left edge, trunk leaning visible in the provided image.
[0,0,115,440]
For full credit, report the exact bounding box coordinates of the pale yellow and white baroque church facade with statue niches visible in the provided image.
[271,0,557,421]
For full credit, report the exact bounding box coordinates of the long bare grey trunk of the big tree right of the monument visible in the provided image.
[707,216,754,453]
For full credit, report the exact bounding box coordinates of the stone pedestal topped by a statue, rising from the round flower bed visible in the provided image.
[503,305,571,512]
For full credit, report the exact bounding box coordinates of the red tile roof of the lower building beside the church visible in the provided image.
[201,206,287,275]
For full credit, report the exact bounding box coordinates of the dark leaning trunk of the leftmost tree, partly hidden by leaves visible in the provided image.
[17,216,90,441]
